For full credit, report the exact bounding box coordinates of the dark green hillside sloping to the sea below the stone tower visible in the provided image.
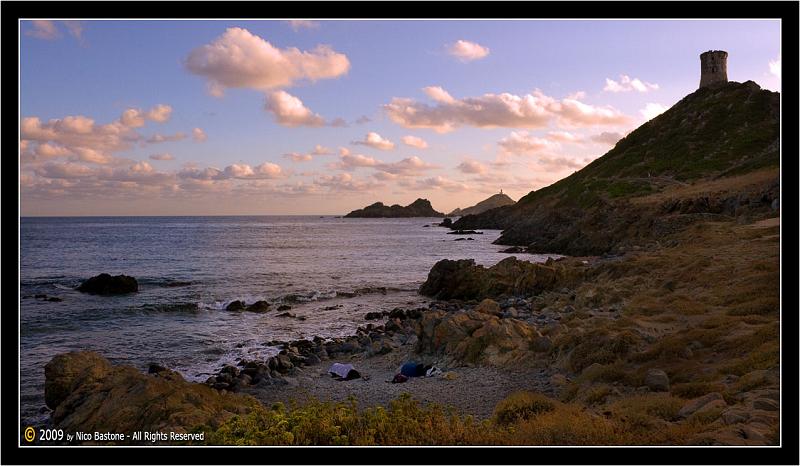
[453,81,780,255]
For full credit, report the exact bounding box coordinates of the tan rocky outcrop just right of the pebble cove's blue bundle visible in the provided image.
[414,310,543,366]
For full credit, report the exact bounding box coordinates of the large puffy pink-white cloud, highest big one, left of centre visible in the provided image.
[186,28,350,96]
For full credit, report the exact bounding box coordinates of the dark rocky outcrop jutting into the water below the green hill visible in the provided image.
[419,257,588,300]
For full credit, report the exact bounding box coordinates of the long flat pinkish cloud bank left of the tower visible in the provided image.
[383,87,630,133]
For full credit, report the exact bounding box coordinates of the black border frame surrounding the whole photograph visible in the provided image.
[0,1,800,464]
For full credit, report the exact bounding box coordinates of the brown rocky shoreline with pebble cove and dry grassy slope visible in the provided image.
[39,208,779,445]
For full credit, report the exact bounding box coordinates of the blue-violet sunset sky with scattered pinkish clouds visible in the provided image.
[20,19,781,216]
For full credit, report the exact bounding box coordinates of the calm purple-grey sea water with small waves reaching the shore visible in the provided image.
[20,216,546,425]
